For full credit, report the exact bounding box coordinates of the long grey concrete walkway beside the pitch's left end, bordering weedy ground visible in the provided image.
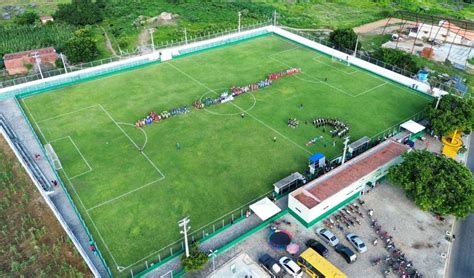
[0,99,108,277]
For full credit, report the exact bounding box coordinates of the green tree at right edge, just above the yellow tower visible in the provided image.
[425,95,474,135]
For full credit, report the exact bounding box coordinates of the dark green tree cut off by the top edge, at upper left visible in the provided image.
[54,0,104,25]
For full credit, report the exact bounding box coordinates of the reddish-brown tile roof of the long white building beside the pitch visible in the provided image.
[292,140,409,209]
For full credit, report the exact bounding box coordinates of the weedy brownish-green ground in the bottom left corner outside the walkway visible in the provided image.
[0,136,92,277]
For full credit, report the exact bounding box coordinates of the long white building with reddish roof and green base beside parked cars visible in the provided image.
[288,140,409,227]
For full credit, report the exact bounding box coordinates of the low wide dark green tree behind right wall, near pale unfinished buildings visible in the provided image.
[373,48,418,73]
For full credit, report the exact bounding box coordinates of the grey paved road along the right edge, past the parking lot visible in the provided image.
[448,134,474,278]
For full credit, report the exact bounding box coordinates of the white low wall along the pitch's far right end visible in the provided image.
[268,26,430,94]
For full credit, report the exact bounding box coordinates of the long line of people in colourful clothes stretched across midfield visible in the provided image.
[135,68,301,127]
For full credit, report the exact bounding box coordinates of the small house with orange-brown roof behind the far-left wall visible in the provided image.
[3,47,58,75]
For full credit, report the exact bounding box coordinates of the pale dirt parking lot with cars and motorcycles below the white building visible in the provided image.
[189,181,453,277]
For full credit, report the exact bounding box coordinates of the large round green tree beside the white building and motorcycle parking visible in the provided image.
[388,151,474,217]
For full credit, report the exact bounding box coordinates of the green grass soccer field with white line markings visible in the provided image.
[21,35,430,269]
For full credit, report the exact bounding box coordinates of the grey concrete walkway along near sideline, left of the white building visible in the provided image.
[144,196,288,278]
